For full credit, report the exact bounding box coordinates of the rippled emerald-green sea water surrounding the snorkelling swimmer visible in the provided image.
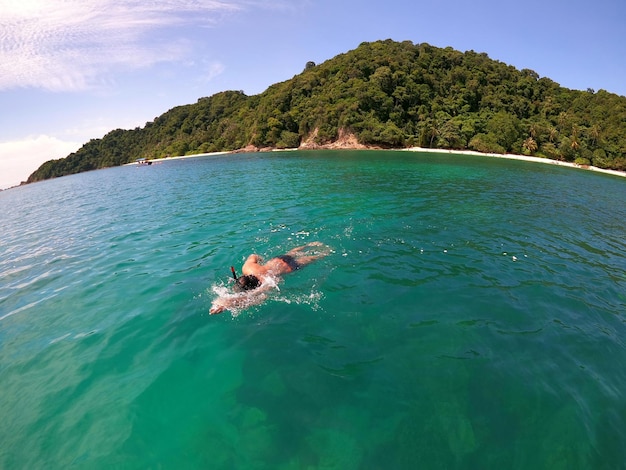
[0,152,626,469]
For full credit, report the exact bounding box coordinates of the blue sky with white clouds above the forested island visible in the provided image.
[0,0,626,188]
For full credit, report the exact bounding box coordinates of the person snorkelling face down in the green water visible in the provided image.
[209,242,329,315]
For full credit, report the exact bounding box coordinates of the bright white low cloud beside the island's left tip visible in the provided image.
[0,135,81,189]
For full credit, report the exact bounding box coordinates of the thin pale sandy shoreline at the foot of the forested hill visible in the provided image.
[126,147,626,178]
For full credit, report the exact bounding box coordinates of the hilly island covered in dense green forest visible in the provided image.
[27,40,626,183]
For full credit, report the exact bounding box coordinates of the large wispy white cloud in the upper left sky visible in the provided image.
[0,0,241,91]
